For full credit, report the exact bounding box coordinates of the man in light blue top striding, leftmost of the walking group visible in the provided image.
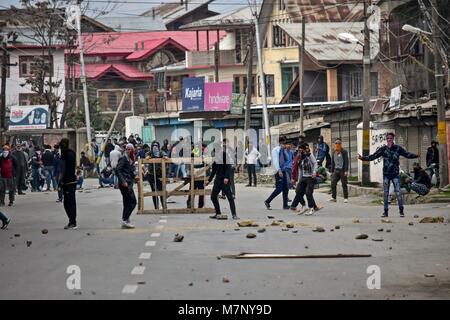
[264,137,290,210]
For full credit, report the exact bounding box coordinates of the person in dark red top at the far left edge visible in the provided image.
[0,145,17,206]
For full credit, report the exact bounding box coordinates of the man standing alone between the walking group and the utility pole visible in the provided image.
[329,139,348,203]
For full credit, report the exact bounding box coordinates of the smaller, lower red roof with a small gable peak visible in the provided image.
[66,63,153,80]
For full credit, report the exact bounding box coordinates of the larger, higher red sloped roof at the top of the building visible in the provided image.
[79,31,226,56]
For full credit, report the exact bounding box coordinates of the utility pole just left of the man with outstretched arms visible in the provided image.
[361,0,371,186]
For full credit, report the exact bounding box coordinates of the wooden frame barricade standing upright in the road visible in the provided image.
[137,157,215,214]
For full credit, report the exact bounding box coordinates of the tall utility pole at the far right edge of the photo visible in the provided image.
[430,0,448,188]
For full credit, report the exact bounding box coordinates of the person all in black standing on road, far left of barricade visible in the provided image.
[59,138,77,230]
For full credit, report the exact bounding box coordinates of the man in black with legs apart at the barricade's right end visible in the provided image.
[206,139,239,220]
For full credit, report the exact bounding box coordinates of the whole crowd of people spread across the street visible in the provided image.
[0,133,439,229]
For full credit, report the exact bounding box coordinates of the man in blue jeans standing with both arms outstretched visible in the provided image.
[358,132,419,218]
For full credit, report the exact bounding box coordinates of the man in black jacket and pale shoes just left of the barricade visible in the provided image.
[116,144,137,229]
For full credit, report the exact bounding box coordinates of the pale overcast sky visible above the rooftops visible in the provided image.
[0,0,248,17]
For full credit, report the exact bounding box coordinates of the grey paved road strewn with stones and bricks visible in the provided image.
[0,180,450,299]
